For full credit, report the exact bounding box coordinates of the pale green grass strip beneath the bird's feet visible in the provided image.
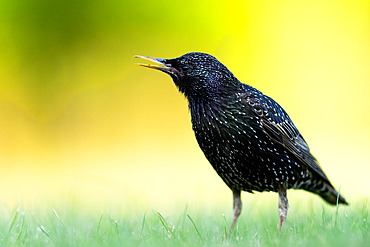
[0,200,370,247]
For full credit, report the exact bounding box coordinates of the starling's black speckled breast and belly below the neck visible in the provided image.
[191,99,301,191]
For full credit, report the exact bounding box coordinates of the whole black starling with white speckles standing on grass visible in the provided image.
[135,52,347,229]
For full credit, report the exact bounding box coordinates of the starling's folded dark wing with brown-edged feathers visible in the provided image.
[243,90,330,184]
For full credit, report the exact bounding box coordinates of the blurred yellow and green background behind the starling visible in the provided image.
[0,0,370,213]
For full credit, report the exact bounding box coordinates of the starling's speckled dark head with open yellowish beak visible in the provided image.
[135,52,238,98]
